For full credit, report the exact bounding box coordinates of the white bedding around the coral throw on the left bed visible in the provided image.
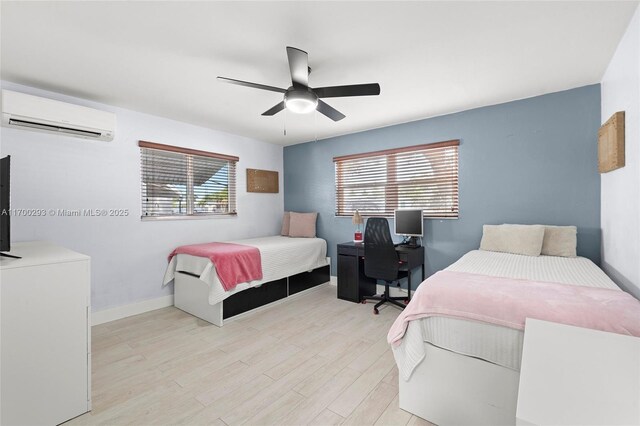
[164,235,329,305]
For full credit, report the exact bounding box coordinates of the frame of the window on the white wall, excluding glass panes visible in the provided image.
[138,140,240,221]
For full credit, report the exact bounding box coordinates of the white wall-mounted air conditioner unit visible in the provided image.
[2,90,116,141]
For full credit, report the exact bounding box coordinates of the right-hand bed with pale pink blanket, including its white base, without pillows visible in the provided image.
[388,250,640,424]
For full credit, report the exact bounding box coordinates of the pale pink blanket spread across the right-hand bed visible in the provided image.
[387,271,640,345]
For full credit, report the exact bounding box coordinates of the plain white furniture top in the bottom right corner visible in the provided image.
[516,319,640,426]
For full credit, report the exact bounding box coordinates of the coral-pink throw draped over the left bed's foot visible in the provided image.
[169,243,262,291]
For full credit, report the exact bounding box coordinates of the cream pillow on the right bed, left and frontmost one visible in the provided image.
[480,224,544,256]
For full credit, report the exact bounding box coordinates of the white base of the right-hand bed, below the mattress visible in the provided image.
[399,343,520,426]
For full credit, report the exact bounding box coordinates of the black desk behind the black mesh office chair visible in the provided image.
[338,242,424,303]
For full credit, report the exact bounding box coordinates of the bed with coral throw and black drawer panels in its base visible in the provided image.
[163,236,329,326]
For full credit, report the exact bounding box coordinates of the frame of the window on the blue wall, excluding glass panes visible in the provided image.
[333,139,460,219]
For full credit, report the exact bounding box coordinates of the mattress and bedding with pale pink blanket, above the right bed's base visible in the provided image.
[388,250,640,380]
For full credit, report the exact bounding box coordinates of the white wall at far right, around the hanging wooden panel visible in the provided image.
[601,5,640,297]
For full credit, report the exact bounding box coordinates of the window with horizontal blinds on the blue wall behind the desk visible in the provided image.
[333,140,460,218]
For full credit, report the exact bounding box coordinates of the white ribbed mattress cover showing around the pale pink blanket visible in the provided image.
[403,250,618,374]
